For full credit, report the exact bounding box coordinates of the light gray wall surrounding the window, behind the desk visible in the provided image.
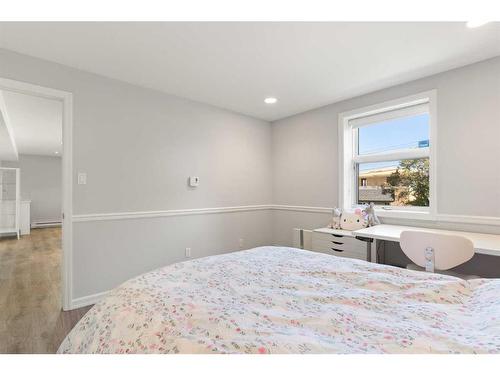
[272,57,500,277]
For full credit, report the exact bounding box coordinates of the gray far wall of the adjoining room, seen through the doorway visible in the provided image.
[2,155,62,223]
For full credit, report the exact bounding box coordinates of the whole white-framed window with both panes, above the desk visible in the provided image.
[339,92,436,218]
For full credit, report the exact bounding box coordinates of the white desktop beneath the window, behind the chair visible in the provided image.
[352,224,500,256]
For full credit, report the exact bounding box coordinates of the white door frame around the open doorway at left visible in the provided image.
[0,77,73,311]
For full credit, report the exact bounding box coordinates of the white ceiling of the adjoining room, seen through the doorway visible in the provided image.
[0,91,62,160]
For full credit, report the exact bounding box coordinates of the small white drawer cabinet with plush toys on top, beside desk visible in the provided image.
[312,228,369,260]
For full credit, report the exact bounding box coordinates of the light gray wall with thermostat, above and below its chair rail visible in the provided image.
[0,49,272,299]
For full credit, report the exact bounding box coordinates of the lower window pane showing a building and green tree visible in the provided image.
[356,158,429,207]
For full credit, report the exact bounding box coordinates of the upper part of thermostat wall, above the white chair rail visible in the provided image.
[0,49,271,214]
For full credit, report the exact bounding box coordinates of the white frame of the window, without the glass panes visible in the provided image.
[338,90,437,220]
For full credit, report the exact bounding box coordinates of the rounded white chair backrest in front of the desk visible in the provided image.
[400,231,474,271]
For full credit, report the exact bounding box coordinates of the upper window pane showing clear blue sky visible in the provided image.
[358,113,429,155]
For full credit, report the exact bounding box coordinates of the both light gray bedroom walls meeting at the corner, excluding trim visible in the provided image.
[0,50,500,298]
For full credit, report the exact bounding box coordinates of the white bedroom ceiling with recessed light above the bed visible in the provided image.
[0,22,500,121]
